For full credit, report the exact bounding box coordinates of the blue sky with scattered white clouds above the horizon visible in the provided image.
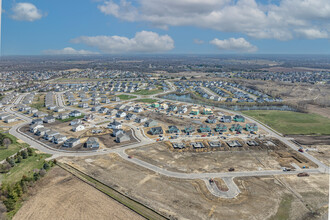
[1,0,330,55]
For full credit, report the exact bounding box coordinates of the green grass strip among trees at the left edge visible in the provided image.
[1,154,51,184]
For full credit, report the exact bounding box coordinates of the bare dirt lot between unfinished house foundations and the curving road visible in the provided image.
[127,143,311,173]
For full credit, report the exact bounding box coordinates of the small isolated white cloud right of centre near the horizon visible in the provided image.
[210,38,258,53]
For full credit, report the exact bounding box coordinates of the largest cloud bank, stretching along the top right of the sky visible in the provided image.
[98,0,330,40]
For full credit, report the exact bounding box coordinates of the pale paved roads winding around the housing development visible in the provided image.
[5,90,329,198]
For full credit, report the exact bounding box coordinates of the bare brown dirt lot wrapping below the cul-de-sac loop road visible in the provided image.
[60,155,329,220]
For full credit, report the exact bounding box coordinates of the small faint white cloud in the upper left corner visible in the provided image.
[11,2,44,22]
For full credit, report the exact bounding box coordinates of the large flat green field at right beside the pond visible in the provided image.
[243,110,330,135]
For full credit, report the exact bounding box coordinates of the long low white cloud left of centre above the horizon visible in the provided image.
[71,31,174,54]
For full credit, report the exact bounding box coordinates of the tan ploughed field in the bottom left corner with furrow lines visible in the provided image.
[13,167,143,220]
